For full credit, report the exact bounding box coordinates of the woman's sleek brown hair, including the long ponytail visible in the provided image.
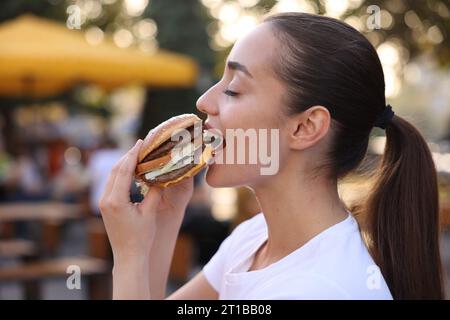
[264,13,443,299]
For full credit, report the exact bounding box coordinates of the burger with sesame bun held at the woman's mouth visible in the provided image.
[135,114,220,193]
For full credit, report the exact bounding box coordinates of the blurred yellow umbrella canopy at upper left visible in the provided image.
[0,15,197,96]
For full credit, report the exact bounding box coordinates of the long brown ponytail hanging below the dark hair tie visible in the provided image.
[361,116,444,299]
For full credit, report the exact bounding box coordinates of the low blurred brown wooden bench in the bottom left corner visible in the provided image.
[0,257,111,299]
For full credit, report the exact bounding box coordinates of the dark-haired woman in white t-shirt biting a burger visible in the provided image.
[100,13,443,299]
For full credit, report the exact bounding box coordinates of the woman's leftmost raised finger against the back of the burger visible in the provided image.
[111,139,142,202]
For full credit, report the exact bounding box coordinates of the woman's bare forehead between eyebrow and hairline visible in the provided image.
[227,23,277,78]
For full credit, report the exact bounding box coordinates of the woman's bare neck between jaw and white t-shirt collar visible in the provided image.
[253,166,348,261]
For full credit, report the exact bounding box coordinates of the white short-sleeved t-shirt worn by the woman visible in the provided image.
[203,213,392,300]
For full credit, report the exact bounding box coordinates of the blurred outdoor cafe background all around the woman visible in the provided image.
[0,0,450,299]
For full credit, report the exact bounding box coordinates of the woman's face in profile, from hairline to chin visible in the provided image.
[197,24,287,187]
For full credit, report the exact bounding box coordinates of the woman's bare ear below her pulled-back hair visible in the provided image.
[289,106,331,150]
